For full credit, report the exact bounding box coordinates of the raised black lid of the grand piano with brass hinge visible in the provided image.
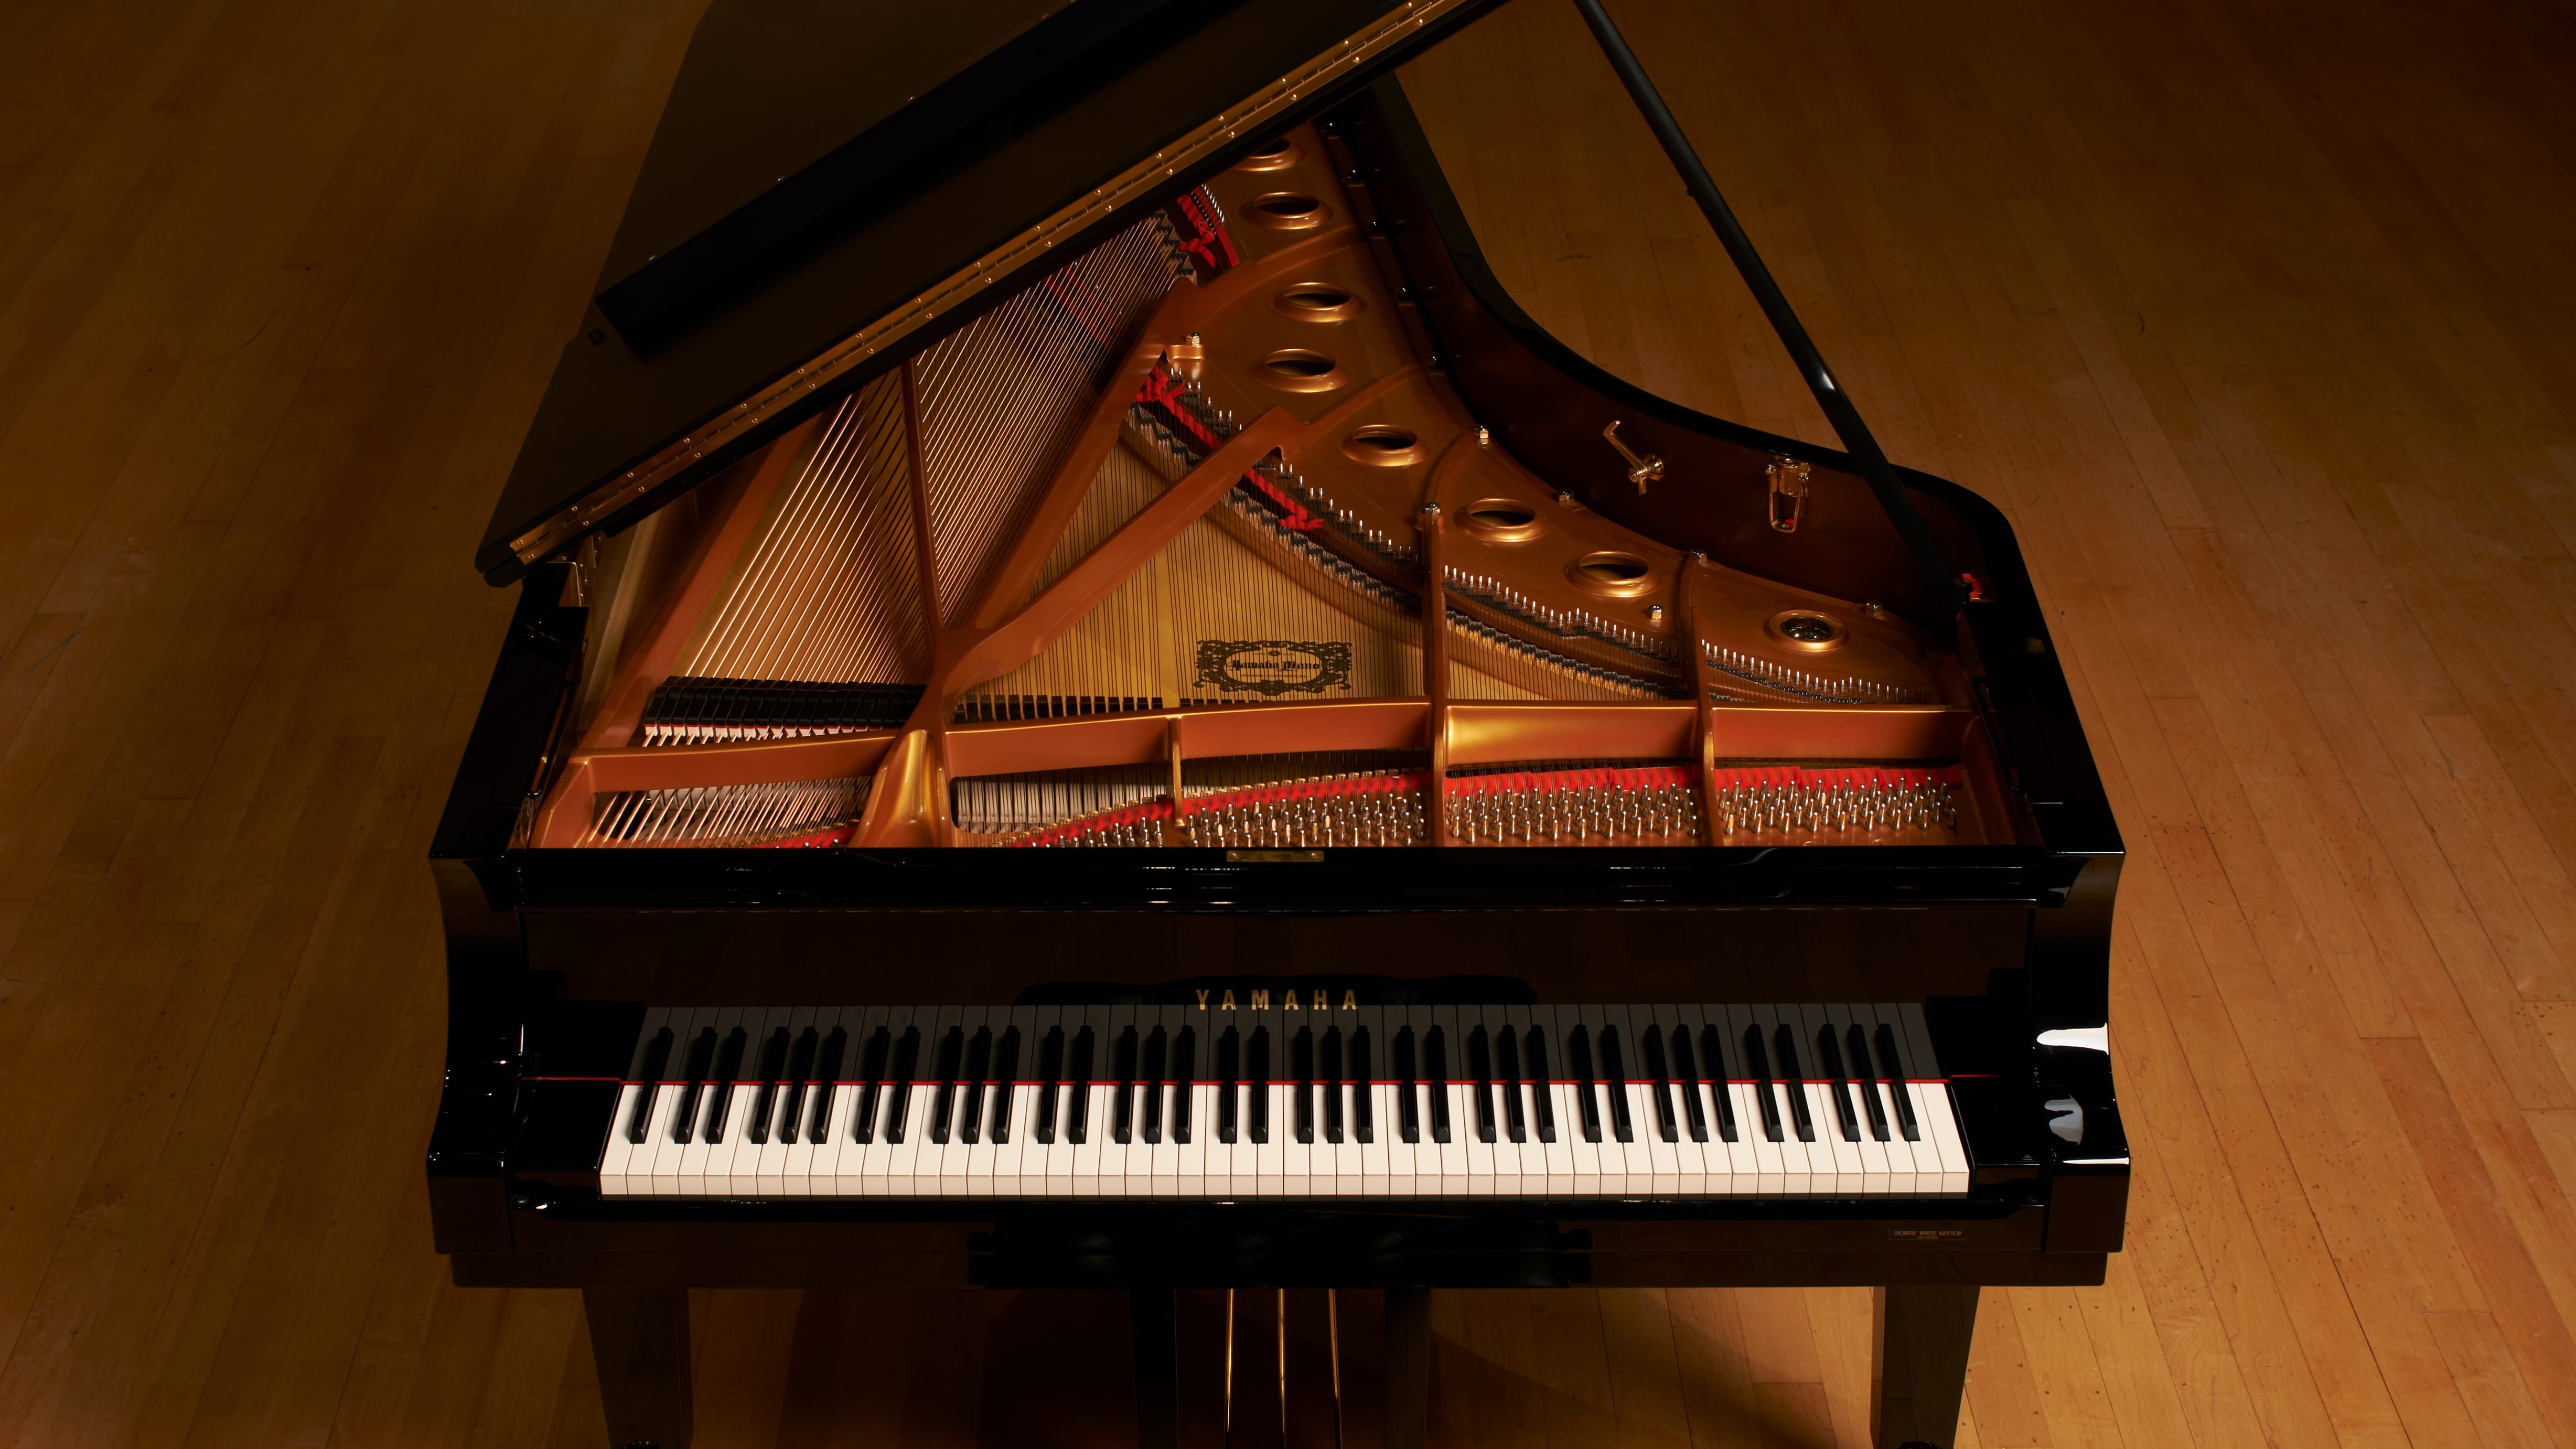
[474,0,1486,583]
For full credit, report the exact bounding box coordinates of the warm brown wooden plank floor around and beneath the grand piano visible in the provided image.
[0,0,2576,1449]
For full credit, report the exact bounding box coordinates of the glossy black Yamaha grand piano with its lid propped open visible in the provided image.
[427,0,2128,1449]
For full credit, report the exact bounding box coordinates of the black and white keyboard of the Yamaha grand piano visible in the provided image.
[598,990,1968,1201]
